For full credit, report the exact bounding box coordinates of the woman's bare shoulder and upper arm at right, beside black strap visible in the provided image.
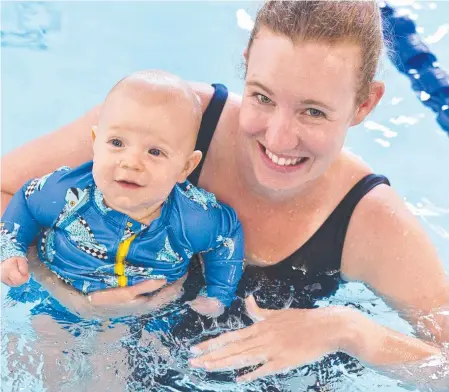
[341,152,444,307]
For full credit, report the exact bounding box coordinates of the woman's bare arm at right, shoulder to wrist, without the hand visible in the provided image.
[342,186,449,385]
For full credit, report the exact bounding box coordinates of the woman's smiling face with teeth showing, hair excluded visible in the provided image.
[239,28,372,195]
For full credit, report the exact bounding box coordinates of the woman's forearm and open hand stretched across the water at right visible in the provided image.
[190,296,448,382]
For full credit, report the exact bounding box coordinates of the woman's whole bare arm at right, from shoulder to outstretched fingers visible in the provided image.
[191,186,449,390]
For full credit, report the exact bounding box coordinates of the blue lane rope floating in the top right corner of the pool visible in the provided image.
[379,3,449,135]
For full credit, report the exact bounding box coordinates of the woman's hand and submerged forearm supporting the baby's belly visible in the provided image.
[28,248,187,318]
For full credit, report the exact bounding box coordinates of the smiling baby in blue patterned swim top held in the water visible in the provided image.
[0,71,244,315]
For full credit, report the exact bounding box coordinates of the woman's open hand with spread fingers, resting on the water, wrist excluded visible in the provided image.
[190,296,352,382]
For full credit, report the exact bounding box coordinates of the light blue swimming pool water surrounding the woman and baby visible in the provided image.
[2,0,449,391]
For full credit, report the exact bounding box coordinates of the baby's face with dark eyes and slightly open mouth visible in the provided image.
[93,87,198,214]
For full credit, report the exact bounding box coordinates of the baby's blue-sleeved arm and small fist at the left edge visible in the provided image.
[0,169,70,286]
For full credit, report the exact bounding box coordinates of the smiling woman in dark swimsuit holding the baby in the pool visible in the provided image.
[2,1,449,381]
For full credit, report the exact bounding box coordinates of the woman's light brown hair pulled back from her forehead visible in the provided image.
[248,0,384,104]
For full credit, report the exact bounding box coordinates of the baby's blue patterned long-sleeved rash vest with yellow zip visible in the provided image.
[0,162,244,306]
